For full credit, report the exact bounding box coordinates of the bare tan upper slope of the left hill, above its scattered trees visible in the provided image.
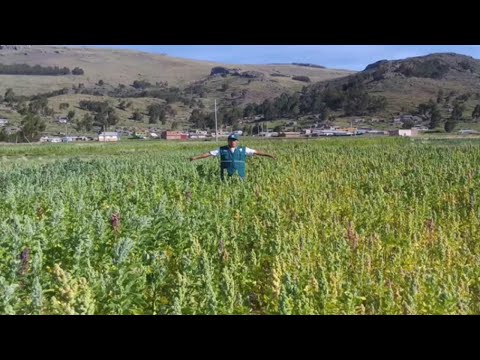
[0,46,353,95]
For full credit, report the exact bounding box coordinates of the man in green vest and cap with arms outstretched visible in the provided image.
[190,134,275,180]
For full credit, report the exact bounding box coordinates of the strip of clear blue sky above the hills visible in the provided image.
[73,45,480,70]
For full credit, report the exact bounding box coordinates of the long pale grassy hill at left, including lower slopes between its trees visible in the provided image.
[0,46,354,132]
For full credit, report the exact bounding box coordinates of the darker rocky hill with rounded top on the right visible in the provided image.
[313,53,480,116]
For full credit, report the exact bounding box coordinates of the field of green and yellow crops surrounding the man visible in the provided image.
[0,138,480,314]
